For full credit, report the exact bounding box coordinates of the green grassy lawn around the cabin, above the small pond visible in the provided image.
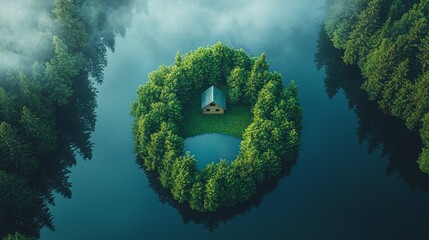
[181,87,252,138]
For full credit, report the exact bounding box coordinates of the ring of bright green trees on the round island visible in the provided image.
[131,43,301,212]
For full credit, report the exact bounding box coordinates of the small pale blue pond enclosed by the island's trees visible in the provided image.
[183,133,241,170]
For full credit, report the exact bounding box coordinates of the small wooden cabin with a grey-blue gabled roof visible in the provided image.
[201,86,226,114]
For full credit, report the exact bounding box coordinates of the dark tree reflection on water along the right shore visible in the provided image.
[315,27,429,192]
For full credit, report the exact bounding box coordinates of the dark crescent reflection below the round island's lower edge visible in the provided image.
[137,155,296,232]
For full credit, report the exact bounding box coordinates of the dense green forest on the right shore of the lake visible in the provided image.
[325,0,429,173]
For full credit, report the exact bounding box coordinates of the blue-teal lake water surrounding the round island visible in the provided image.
[41,0,429,240]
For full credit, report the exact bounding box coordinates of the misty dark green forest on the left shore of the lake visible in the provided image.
[0,0,134,239]
